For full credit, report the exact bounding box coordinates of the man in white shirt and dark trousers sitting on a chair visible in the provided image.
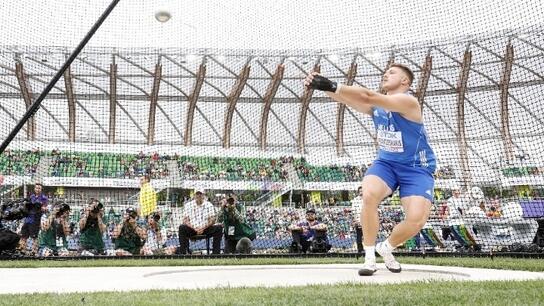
[179,189,223,254]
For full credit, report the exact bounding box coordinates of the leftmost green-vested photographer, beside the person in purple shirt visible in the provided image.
[39,202,70,257]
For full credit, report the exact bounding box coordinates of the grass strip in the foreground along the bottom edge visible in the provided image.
[0,281,544,306]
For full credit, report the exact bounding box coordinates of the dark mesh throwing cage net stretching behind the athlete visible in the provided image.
[0,0,544,256]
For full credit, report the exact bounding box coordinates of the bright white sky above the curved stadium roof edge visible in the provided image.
[0,0,544,49]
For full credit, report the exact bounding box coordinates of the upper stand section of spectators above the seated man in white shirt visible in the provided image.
[178,156,289,181]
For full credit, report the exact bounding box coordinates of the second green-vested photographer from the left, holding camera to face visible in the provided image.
[79,198,106,256]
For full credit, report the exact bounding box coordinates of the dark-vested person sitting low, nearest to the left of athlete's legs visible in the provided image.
[289,208,331,253]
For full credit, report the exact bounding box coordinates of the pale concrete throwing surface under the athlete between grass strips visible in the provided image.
[0,264,544,294]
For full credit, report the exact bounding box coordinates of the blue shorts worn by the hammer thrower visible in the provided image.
[365,159,434,203]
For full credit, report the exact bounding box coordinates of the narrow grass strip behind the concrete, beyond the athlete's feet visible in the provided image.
[0,257,544,271]
